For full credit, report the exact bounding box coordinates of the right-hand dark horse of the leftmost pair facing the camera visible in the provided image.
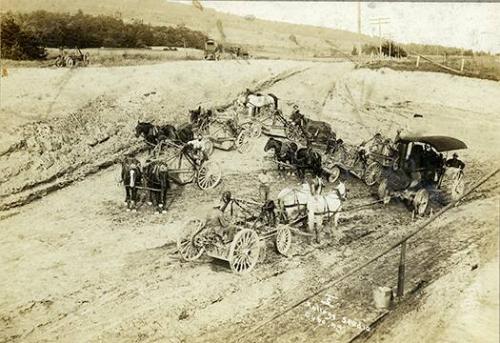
[144,161,170,213]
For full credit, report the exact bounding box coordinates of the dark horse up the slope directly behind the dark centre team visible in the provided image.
[290,111,336,153]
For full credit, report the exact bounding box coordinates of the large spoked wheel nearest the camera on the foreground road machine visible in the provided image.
[229,229,261,273]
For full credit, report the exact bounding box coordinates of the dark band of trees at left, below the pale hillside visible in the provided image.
[1,11,208,59]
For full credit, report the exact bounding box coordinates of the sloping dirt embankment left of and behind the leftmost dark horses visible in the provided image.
[0,61,316,209]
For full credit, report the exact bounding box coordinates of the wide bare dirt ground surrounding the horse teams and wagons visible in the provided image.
[0,60,500,342]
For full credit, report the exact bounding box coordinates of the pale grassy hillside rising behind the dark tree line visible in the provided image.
[2,0,372,57]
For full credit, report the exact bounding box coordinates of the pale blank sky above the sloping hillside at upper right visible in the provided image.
[171,0,500,53]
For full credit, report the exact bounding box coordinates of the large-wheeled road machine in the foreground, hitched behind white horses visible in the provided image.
[177,192,292,273]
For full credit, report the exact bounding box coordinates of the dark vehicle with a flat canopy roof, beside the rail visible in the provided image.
[377,136,467,215]
